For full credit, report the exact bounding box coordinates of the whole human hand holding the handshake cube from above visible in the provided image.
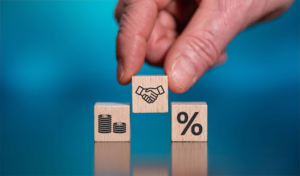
[115,0,293,93]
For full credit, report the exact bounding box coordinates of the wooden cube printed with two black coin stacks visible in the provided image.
[94,103,130,141]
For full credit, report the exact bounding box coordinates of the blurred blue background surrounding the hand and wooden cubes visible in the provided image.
[1,1,300,175]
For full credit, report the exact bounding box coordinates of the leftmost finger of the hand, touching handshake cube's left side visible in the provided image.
[116,0,171,84]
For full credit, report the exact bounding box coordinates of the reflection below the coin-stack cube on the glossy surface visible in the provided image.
[94,142,130,176]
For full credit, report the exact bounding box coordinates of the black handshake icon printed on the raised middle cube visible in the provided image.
[135,86,165,104]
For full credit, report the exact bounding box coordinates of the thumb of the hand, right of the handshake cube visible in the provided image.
[164,0,255,93]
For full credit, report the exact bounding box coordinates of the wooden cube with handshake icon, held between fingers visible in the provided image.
[132,75,168,113]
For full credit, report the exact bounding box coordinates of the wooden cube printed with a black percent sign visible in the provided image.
[171,102,207,141]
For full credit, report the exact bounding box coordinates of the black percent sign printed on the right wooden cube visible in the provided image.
[177,112,202,136]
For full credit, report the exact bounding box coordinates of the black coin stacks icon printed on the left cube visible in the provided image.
[98,114,126,133]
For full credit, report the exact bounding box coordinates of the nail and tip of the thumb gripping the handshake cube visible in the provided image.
[172,56,197,91]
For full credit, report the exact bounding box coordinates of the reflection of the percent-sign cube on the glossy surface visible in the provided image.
[172,142,207,176]
